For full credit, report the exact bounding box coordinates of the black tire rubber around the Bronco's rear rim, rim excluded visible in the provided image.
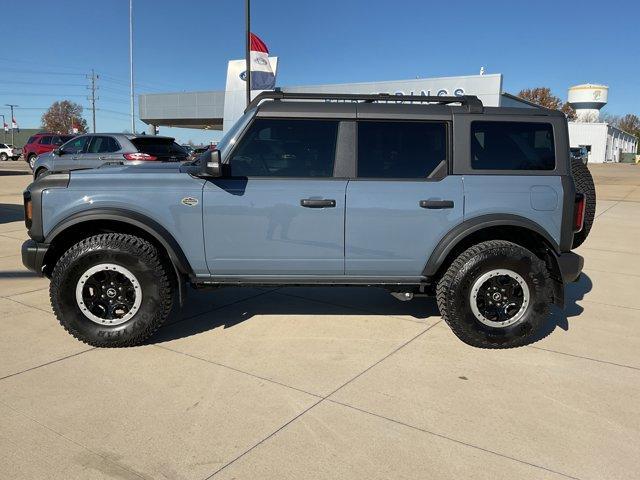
[436,240,552,348]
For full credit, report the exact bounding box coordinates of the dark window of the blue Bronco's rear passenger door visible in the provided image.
[358,121,447,178]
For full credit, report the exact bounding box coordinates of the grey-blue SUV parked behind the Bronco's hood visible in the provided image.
[33,133,187,178]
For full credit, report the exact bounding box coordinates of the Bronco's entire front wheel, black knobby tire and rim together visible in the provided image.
[50,233,173,347]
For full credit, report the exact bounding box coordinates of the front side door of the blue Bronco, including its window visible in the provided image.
[203,118,347,277]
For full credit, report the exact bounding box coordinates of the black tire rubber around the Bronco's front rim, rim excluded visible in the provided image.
[49,233,175,347]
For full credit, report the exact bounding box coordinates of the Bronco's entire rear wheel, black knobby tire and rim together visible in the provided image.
[437,240,552,348]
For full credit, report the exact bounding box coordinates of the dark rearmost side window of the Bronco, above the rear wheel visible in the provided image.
[471,122,556,170]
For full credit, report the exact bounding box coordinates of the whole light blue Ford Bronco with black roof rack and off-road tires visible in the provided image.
[22,91,595,348]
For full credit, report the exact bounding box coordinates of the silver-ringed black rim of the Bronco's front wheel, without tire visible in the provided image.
[76,263,142,326]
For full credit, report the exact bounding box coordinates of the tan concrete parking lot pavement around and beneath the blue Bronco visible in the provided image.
[0,162,640,480]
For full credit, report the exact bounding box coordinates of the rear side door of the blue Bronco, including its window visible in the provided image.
[345,120,463,278]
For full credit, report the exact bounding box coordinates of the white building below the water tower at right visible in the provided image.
[569,122,638,163]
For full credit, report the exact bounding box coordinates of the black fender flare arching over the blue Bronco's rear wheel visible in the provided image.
[422,213,560,277]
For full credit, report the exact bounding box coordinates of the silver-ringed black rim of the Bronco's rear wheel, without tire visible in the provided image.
[469,269,531,328]
